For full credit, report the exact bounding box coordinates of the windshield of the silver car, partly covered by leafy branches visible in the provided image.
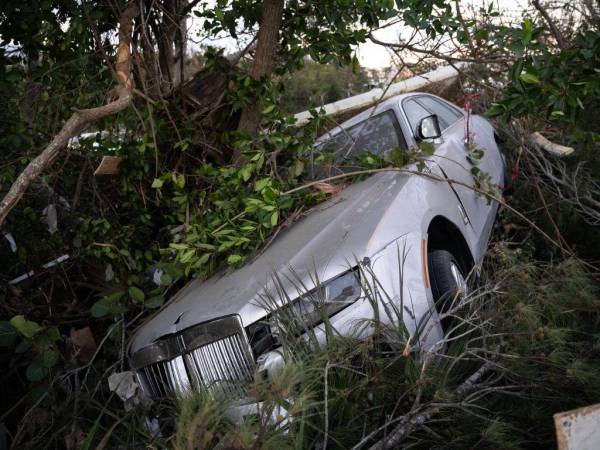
[312,111,407,178]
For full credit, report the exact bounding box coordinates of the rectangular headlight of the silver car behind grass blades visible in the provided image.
[269,269,361,335]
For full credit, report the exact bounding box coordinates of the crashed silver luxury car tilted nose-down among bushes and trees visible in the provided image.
[128,93,504,399]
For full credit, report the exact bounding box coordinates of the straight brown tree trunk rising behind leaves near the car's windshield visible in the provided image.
[234,0,283,156]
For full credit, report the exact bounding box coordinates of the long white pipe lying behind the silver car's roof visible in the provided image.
[294,63,468,126]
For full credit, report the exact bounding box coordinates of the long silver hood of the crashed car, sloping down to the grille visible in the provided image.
[130,171,407,353]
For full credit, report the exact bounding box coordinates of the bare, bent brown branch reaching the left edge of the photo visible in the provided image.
[0,1,138,228]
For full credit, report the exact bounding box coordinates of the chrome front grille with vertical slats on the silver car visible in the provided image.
[130,316,254,399]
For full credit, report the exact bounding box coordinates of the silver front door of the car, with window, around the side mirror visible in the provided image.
[402,95,493,236]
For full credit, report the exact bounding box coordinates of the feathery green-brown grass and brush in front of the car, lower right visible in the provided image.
[166,245,600,449]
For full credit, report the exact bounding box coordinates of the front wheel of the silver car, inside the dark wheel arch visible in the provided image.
[428,250,469,332]
